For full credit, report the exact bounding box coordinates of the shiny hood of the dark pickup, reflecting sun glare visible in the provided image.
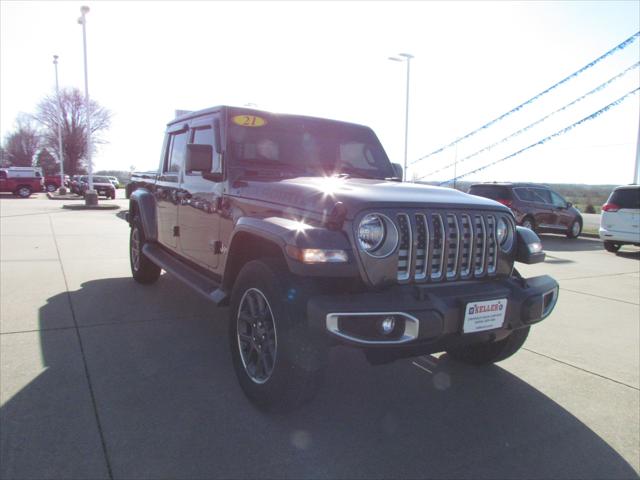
[230,177,509,218]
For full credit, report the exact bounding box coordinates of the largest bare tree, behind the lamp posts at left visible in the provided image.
[35,88,111,175]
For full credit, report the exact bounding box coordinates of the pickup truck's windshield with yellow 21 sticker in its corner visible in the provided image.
[227,115,394,179]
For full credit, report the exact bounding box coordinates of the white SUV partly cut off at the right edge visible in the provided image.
[599,185,640,253]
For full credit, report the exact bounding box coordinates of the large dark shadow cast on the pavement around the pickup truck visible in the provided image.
[0,276,637,479]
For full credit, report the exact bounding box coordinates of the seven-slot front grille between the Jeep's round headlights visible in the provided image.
[396,212,498,282]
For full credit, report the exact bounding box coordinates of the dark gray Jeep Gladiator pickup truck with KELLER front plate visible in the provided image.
[128,106,558,410]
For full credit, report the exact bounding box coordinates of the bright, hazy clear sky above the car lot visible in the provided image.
[0,0,640,184]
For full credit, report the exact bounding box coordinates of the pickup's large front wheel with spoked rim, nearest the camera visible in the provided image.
[229,258,327,412]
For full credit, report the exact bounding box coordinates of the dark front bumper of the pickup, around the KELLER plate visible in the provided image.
[307,275,558,354]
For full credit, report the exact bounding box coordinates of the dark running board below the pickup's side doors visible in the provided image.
[142,243,228,306]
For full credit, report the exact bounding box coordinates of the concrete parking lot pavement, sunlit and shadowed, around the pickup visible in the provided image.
[0,192,640,479]
